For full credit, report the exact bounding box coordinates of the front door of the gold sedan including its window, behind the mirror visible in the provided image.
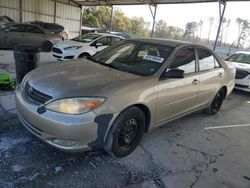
[156,48,199,123]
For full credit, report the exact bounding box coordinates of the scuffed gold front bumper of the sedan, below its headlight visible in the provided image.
[16,89,105,152]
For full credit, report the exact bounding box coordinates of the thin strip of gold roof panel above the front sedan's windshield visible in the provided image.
[127,38,192,47]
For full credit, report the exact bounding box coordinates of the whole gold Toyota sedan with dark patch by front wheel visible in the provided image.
[16,39,235,157]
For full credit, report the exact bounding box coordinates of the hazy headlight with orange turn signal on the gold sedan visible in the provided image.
[45,97,105,114]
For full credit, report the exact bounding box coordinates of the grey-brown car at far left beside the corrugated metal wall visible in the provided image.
[0,23,62,52]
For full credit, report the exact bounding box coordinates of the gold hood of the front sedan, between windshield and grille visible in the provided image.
[25,60,143,99]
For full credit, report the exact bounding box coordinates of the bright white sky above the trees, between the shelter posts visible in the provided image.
[114,2,250,44]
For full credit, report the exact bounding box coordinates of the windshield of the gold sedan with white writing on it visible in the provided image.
[91,41,174,76]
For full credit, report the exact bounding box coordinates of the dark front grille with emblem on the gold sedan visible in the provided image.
[24,82,52,104]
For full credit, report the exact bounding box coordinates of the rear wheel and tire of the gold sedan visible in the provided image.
[205,88,226,115]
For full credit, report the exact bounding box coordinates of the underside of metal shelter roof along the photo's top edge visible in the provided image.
[73,0,234,6]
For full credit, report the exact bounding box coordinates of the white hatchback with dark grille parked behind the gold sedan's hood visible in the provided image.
[52,33,123,60]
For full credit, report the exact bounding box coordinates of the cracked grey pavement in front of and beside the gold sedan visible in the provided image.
[0,91,250,188]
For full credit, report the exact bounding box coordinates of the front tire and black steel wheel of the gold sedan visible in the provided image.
[104,106,146,157]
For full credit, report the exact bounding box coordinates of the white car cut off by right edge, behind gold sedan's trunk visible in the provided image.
[225,51,250,92]
